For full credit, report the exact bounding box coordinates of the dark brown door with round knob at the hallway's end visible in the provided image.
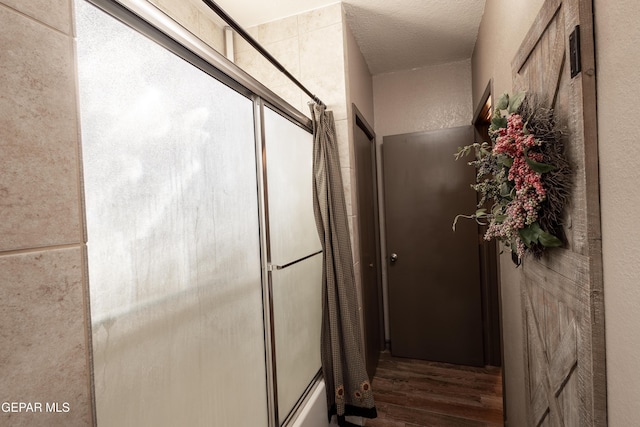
[382,126,483,365]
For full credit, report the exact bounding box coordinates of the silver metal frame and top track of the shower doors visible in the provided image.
[80,0,321,427]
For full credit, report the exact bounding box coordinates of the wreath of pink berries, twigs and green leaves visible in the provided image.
[453,92,571,265]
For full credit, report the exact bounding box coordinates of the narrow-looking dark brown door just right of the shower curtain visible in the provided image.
[353,106,384,378]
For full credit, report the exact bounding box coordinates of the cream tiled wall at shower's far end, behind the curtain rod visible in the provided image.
[234,3,361,309]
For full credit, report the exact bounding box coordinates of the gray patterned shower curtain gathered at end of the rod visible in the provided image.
[310,104,376,426]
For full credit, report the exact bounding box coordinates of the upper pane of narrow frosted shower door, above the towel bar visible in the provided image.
[264,108,322,265]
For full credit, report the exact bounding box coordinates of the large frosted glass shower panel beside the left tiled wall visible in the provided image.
[75,0,268,427]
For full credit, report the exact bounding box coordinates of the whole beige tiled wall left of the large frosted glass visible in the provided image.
[0,0,93,426]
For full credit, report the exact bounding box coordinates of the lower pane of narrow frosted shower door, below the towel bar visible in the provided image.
[271,254,322,423]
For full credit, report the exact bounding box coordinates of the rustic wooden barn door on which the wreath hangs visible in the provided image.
[512,0,607,427]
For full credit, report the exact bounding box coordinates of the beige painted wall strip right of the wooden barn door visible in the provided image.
[594,0,640,427]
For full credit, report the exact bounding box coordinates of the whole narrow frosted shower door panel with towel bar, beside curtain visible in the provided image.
[264,108,322,423]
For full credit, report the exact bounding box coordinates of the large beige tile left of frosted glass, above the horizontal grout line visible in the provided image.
[0,7,83,250]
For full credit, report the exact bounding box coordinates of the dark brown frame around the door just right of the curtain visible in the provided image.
[350,103,385,376]
